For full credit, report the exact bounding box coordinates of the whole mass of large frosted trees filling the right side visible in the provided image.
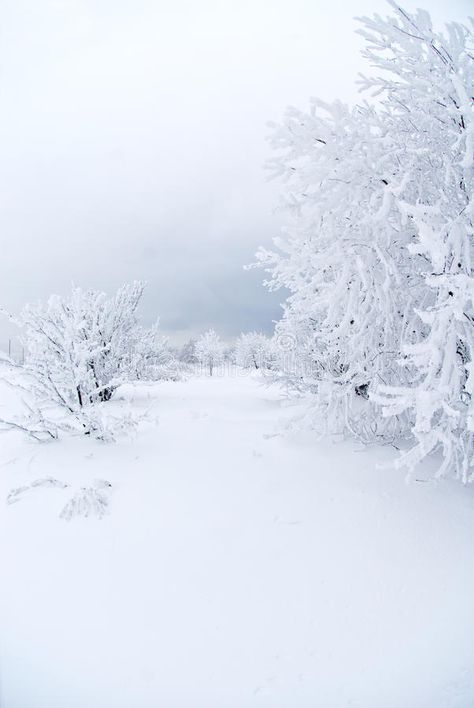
[259,2,474,480]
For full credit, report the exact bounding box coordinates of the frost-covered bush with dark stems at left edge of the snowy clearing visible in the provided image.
[1,282,165,440]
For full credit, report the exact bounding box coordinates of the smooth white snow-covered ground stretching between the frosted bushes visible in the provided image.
[0,376,474,708]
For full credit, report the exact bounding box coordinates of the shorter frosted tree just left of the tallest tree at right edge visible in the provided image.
[259,85,421,439]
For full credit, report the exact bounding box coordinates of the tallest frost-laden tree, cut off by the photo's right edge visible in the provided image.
[362,5,474,481]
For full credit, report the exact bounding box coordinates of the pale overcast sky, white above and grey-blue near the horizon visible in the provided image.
[0,0,473,344]
